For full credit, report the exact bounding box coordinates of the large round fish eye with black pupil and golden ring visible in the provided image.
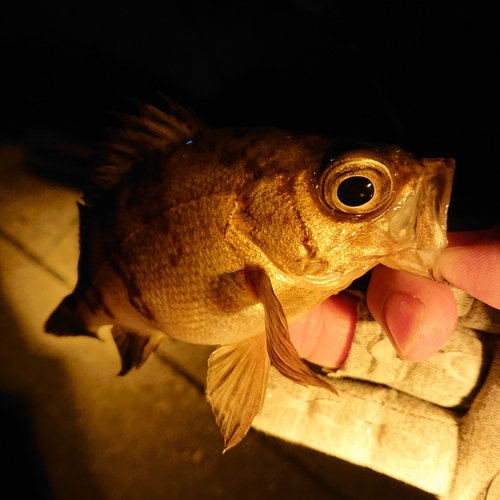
[316,150,393,219]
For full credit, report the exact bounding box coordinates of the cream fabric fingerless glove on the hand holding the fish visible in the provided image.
[254,290,500,500]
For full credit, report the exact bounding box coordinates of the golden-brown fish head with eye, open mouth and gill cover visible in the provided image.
[242,138,454,293]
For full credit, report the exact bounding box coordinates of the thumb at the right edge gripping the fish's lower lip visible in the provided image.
[439,226,500,309]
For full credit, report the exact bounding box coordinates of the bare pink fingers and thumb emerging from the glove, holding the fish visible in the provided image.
[290,226,500,368]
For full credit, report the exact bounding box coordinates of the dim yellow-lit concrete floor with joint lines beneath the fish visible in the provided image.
[0,145,433,500]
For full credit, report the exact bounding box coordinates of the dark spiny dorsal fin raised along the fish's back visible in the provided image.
[83,94,207,205]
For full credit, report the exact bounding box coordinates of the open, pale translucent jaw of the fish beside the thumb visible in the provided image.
[380,158,455,281]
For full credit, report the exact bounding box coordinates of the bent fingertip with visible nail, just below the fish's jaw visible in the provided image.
[367,266,458,361]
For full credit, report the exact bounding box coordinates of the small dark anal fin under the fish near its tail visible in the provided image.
[111,325,164,375]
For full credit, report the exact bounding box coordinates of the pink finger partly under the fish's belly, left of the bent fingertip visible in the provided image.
[289,293,357,369]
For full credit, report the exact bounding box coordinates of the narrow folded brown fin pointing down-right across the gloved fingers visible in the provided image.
[246,269,337,394]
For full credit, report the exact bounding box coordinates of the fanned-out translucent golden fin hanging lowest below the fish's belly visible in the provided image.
[207,334,269,451]
